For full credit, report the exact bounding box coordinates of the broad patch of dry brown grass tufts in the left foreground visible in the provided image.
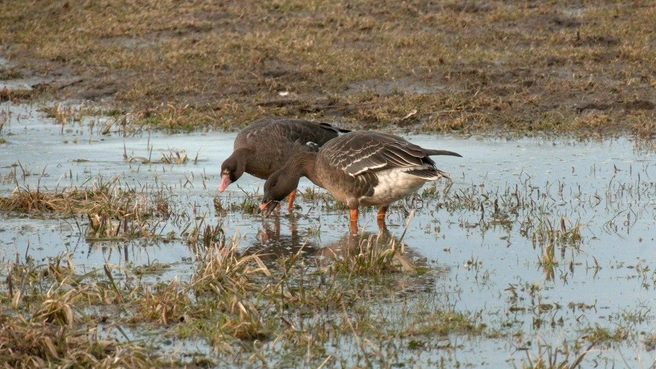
[0,224,462,367]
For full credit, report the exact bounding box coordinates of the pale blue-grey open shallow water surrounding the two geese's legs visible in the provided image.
[0,103,656,368]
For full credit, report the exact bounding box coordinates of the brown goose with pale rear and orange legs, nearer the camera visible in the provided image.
[260,132,461,233]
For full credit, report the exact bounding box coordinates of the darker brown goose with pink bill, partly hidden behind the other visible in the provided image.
[218,116,349,210]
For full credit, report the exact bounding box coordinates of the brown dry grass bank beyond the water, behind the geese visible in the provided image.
[0,0,656,137]
